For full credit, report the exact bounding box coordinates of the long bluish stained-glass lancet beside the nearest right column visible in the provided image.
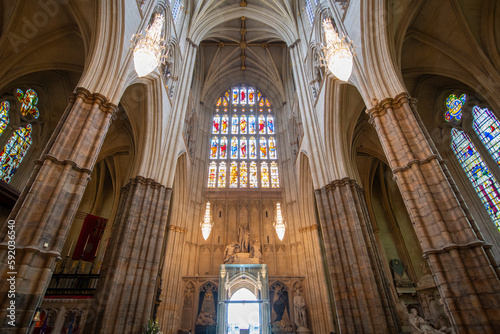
[451,129,500,231]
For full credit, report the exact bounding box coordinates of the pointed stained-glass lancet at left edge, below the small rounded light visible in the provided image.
[0,124,31,183]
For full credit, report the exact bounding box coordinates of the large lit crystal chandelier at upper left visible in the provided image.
[131,14,165,77]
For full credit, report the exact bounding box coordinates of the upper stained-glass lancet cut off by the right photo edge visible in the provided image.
[472,106,500,166]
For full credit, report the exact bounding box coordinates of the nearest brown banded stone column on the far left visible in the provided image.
[0,88,117,333]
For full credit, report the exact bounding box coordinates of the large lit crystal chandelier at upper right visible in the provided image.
[322,19,352,81]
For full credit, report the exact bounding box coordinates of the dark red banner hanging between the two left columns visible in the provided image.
[73,215,108,262]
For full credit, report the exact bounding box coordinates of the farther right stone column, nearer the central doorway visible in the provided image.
[316,178,398,333]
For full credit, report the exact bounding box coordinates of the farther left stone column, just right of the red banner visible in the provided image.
[84,176,172,334]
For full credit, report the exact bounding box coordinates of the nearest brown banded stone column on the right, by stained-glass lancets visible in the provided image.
[367,93,500,333]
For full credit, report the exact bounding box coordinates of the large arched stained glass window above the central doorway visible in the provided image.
[207,85,279,189]
